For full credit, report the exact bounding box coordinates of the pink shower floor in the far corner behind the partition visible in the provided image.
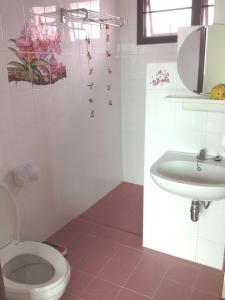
[80,182,143,234]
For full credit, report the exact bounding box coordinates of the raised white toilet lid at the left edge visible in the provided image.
[0,185,17,249]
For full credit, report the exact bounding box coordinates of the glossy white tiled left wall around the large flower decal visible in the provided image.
[0,0,122,240]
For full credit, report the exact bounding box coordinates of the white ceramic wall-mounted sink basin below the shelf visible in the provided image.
[150,151,225,201]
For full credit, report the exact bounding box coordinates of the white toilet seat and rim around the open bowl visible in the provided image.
[0,242,70,299]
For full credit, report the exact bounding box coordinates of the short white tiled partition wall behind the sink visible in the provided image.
[144,62,225,269]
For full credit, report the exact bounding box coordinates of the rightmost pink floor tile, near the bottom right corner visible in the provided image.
[196,267,223,296]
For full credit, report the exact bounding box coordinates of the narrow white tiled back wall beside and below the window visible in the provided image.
[120,0,176,184]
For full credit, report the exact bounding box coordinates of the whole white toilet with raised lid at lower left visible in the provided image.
[0,185,70,300]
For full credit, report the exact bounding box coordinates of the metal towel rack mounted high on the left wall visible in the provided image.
[60,8,125,27]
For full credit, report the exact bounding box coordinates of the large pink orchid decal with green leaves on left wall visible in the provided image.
[8,23,66,85]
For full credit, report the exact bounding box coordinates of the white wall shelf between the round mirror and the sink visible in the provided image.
[165,96,225,113]
